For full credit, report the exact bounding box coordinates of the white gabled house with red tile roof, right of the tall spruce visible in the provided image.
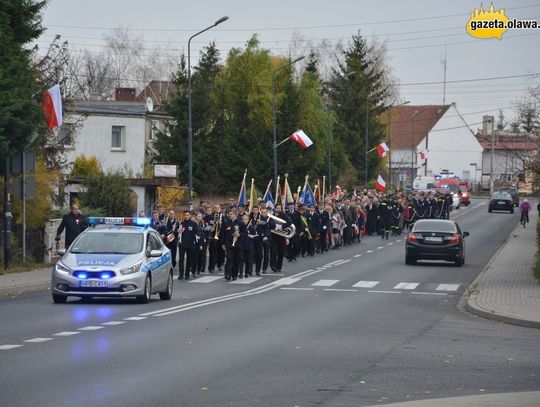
[387,104,483,187]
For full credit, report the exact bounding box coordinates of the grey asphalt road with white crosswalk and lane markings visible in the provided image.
[0,201,540,407]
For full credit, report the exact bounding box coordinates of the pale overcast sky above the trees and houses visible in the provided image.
[38,0,540,128]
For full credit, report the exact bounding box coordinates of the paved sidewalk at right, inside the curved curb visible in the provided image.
[466,209,540,328]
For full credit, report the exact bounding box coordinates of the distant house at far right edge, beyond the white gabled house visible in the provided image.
[476,116,538,190]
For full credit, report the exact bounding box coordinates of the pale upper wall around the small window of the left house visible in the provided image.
[67,115,147,176]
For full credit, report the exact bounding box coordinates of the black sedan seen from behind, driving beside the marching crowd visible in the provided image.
[405,219,469,267]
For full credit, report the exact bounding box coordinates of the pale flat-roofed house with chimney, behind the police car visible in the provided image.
[60,85,175,212]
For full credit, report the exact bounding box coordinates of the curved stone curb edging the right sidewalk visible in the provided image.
[460,220,540,329]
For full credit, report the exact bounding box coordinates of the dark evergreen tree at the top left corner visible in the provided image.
[0,0,46,156]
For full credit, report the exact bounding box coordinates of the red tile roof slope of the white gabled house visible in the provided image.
[390,105,451,149]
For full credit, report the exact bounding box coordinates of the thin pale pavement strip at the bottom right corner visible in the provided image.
[364,391,540,407]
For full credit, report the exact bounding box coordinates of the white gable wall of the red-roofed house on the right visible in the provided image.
[417,106,483,180]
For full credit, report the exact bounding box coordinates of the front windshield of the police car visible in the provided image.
[70,232,144,254]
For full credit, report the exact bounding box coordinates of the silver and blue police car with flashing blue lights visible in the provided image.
[51,217,173,303]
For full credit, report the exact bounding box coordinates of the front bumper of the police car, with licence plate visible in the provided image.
[51,269,146,298]
